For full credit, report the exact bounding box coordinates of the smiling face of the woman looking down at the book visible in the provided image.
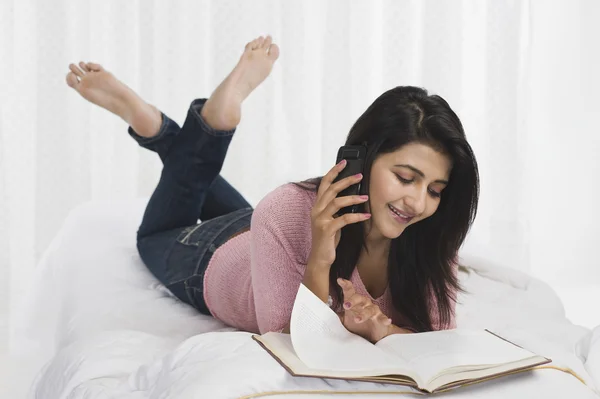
[367,143,452,240]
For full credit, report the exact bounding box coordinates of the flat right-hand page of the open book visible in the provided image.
[377,329,535,380]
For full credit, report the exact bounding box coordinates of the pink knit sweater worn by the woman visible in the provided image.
[204,184,458,334]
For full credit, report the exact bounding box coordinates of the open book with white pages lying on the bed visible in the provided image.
[253,285,551,392]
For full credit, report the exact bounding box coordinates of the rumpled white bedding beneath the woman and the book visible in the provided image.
[12,199,600,399]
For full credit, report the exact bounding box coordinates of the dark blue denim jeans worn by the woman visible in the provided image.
[128,99,253,314]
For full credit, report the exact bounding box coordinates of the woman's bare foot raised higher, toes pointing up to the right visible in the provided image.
[202,36,279,130]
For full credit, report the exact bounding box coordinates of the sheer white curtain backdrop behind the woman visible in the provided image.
[0,0,600,350]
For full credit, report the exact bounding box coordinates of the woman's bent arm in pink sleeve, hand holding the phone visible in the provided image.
[250,160,371,333]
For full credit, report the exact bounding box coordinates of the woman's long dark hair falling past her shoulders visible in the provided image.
[294,86,479,332]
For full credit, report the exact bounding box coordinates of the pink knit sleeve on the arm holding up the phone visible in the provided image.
[250,184,312,334]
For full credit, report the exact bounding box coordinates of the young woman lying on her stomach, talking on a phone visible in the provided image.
[67,36,479,342]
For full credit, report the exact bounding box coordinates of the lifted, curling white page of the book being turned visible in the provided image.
[290,284,404,371]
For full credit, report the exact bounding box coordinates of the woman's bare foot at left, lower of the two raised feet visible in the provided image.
[67,62,162,137]
